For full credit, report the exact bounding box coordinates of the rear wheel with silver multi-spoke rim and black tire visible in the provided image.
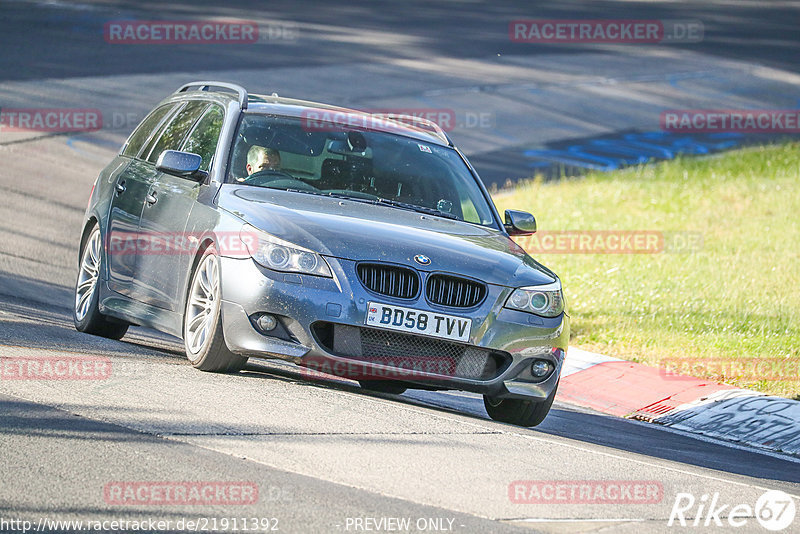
[72,223,130,339]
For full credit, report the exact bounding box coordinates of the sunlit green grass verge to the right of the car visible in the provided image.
[494,143,800,398]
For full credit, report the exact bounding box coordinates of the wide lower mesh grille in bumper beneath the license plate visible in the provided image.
[315,323,510,380]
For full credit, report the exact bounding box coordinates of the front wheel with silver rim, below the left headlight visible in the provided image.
[183,245,247,373]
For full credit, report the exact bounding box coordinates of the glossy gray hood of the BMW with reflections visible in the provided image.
[219,184,555,287]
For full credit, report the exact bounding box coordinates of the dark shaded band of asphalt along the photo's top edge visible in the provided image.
[0,0,800,82]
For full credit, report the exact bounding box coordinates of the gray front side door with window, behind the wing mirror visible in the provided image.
[136,102,223,311]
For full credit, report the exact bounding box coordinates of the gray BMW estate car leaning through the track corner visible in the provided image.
[74,82,569,426]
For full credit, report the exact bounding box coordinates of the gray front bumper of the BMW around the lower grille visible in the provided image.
[220,257,569,400]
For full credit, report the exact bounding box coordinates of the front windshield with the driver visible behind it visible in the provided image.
[228,114,495,226]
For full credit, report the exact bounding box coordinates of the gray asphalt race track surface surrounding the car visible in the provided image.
[0,1,800,532]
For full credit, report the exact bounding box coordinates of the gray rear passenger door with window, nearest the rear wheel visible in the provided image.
[106,104,176,295]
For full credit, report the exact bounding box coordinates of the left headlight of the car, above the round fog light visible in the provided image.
[239,224,332,278]
